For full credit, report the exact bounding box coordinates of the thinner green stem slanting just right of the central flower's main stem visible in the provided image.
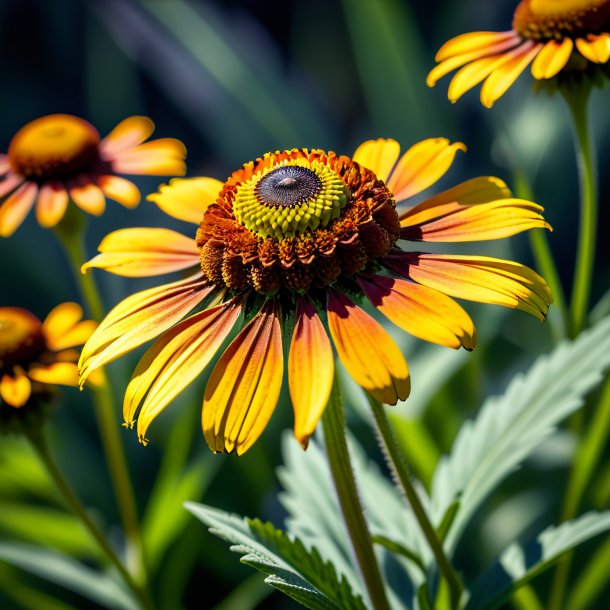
[369,396,464,608]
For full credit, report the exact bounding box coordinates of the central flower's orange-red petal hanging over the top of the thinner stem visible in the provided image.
[328,289,411,405]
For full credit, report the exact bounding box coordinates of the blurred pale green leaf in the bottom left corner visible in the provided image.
[0,542,138,610]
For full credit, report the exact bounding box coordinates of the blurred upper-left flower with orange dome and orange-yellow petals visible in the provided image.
[0,114,186,237]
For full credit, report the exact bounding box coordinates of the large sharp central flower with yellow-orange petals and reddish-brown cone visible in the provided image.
[79,138,551,454]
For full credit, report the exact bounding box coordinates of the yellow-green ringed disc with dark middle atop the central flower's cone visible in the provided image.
[233,158,349,240]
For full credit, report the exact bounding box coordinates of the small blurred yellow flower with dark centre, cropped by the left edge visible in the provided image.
[0,303,96,409]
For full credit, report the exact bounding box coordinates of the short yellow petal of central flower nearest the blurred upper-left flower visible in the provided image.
[147,178,222,225]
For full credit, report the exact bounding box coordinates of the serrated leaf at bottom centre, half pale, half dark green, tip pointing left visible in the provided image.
[186,502,366,610]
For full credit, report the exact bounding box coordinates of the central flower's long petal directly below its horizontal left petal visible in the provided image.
[79,273,213,384]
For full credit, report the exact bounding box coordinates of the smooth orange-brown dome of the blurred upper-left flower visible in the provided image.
[8,114,100,180]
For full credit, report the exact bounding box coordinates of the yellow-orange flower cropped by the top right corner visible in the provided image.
[427,0,610,108]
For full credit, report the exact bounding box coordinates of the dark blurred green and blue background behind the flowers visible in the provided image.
[0,0,610,610]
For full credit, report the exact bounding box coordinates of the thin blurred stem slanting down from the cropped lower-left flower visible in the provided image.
[27,429,152,609]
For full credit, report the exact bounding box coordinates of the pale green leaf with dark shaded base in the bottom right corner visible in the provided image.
[466,511,610,610]
